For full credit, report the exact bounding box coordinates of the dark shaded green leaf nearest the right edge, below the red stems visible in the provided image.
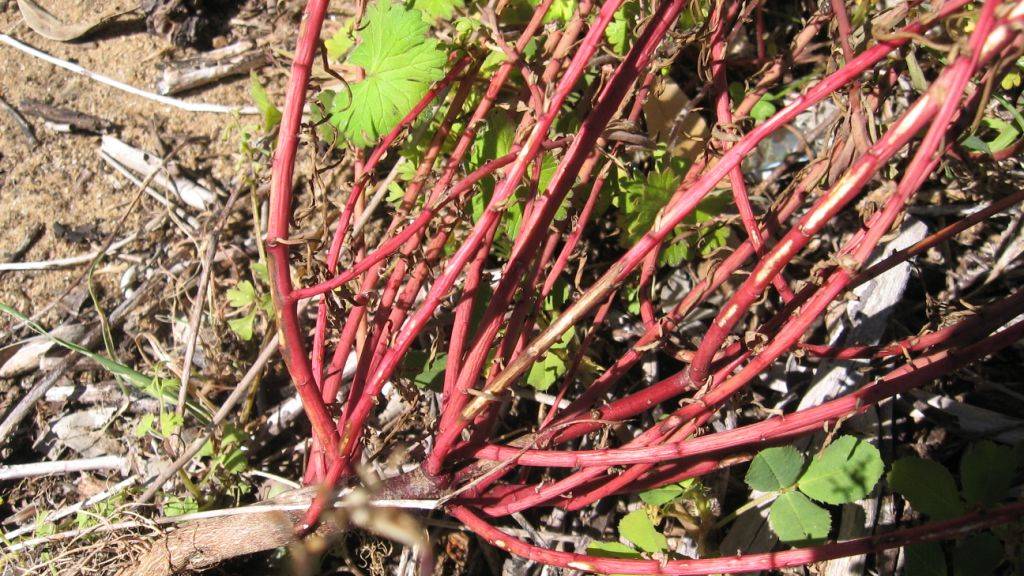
[961,440,1017,505]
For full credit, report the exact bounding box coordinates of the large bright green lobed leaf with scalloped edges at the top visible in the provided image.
[331,0,446,148]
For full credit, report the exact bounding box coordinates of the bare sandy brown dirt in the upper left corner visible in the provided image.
[0,0,278,313]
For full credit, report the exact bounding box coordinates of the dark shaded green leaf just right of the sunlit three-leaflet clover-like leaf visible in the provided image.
[888,456,964,520]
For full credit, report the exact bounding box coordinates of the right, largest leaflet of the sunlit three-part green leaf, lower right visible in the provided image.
[798,436,885,504]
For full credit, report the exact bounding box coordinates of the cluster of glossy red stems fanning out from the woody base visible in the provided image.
[266,0,1024,574]
